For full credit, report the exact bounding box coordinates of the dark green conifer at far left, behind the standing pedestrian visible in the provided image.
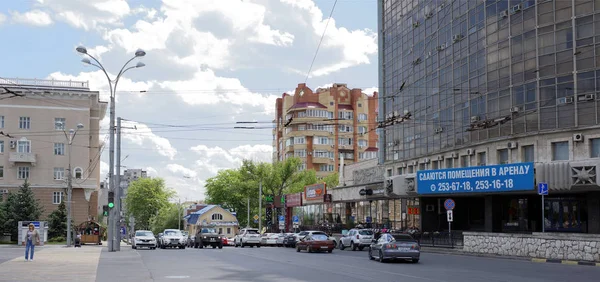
[4,179,43,241]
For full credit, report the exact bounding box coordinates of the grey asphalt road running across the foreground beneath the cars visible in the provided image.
[97,247,600,282]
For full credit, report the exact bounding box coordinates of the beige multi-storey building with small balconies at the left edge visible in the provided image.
[0,79,107,224]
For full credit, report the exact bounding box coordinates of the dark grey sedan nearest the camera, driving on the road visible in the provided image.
[369,233,421,263]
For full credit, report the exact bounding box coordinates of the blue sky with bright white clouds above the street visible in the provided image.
[0,0,377,201]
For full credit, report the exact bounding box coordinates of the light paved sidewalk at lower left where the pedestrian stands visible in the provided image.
[0,246,103,282]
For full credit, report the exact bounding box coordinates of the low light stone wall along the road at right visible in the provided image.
[463,232,600,262]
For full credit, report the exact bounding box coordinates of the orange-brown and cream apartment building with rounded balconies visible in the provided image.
[273,83,378,177]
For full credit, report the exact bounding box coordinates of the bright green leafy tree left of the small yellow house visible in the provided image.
[125,178,175,229]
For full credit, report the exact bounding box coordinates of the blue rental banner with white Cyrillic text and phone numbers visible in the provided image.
[417,163,535,194]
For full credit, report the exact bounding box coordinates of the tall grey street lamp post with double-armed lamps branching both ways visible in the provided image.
[75,46,146,252]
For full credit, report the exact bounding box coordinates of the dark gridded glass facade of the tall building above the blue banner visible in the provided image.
[380,0,600,162]
